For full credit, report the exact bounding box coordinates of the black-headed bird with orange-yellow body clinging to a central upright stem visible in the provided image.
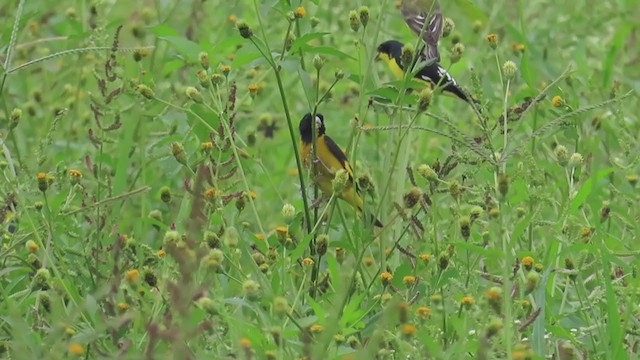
[298,113,383,227]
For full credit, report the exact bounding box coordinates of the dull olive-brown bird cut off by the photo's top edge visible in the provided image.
[400,0,442,61]
